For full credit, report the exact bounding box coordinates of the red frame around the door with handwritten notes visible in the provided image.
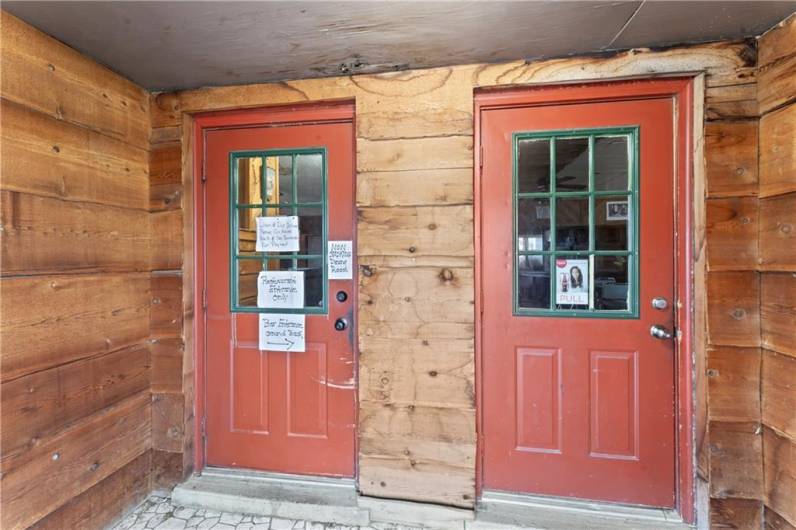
[190,100,359,474]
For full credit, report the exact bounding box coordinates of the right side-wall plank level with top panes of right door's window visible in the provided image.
[760,105,796,197]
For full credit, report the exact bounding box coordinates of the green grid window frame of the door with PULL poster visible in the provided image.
[512,126,640,319]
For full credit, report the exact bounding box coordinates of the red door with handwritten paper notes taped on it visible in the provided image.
[204,111,356,477]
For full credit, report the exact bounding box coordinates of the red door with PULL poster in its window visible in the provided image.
[480,84,676,507]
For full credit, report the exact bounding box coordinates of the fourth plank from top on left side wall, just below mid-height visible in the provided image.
[0,274,149,382]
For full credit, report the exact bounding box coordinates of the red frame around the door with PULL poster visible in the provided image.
[473,74,702,523]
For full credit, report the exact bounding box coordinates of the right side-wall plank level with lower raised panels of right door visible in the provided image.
[760,351,796,440]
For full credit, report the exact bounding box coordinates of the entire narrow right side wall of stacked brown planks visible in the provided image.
[758,16,796,529]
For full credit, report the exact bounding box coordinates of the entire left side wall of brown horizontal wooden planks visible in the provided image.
[0,12,151,530]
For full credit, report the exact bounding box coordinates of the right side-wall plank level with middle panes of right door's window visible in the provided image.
[759,192,796,272]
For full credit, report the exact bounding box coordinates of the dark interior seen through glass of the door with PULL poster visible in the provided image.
[515,133,636,311]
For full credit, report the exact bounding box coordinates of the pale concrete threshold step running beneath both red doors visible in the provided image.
[172,468,692,530]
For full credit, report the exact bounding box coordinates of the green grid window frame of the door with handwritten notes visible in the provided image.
[229,147,329,314]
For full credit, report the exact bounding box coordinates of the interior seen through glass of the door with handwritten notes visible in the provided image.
[233,153,325,309]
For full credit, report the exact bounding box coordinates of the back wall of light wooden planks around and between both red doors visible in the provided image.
[151,37,763,513]
